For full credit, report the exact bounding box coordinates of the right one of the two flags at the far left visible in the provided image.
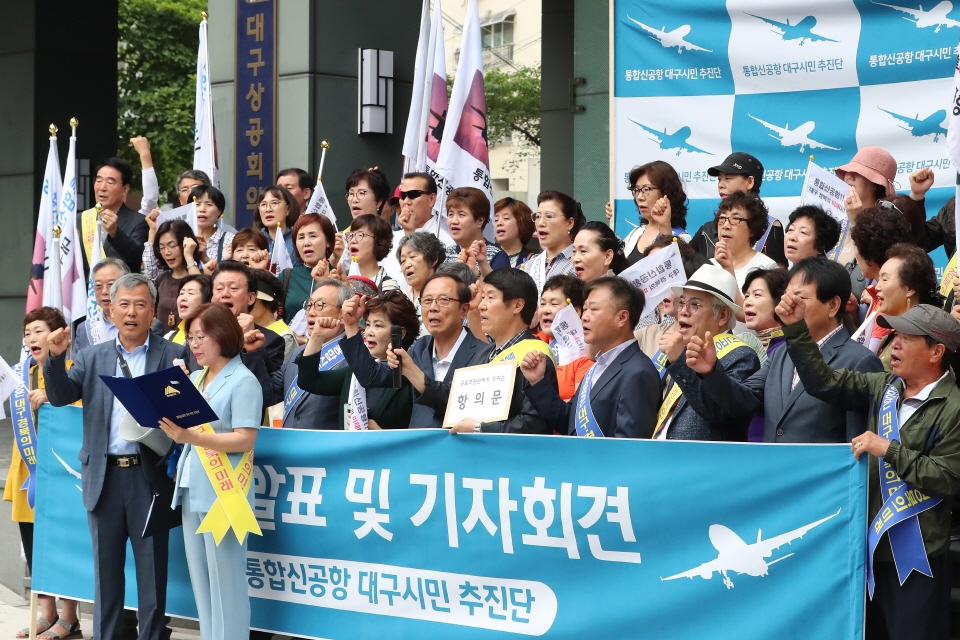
[57,129,87,324]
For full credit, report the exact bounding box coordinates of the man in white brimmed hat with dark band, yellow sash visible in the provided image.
[653,264,760,442]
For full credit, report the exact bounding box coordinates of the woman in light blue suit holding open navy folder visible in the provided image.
[160,303,263,640]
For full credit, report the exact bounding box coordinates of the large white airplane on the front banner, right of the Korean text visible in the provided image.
[660,509,841,589]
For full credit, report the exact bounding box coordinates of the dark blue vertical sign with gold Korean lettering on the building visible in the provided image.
[234,0,277,229]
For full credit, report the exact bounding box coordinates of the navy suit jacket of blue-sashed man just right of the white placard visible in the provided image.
[517,340,661,438]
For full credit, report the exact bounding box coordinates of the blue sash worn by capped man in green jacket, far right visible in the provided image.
[867,384,941,599]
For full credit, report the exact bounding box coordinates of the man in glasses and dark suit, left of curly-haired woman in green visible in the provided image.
[261,278,350,430]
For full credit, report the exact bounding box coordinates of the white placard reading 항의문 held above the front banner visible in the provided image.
[443,360,517,427]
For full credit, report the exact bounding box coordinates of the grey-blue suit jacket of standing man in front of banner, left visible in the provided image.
[43,336,180,511]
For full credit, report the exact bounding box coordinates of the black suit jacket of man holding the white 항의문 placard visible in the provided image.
[418,330,559,434]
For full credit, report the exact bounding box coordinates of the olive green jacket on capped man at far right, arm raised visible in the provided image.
[783,321,960,561]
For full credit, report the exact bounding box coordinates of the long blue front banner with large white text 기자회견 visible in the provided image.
[34,405,867,640]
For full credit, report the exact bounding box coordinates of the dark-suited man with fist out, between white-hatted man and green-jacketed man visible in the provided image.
[687,258,883,443]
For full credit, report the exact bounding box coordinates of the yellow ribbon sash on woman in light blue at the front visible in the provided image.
[194,423,263,546]
